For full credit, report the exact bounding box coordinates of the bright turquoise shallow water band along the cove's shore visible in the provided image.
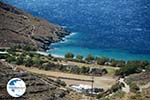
[47,33,150,61]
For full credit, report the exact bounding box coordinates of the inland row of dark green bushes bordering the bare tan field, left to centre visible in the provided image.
[3,52,107,75]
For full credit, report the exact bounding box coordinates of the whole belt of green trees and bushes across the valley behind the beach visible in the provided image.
[0,49,150,76]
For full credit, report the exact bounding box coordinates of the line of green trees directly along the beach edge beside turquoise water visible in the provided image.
[65,52,150,67]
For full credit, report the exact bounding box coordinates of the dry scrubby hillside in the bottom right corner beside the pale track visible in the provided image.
[100,72,150,100]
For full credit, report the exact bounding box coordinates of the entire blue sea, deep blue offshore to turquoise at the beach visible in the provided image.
[0,0,150,60]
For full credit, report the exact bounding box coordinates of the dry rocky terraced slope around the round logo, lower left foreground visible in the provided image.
[0,61,82,100]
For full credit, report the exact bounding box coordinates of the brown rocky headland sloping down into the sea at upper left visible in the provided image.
[0,2,70,50]
